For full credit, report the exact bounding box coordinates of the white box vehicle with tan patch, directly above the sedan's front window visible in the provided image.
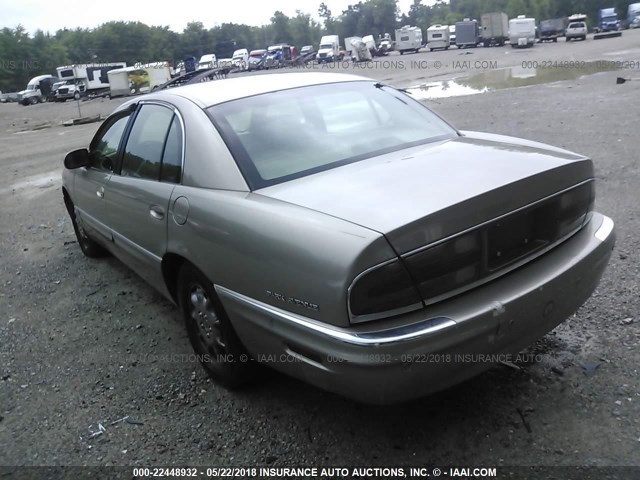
[107,62,171,98]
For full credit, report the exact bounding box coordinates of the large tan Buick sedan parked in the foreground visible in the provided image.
[62,73,615,403]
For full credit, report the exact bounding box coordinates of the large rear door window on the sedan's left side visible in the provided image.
[120,105,174,180]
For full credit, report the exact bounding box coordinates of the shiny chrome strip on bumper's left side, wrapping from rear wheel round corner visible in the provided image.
[214,285,457,347]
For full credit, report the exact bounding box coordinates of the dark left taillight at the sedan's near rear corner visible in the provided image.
[349,260,422,322]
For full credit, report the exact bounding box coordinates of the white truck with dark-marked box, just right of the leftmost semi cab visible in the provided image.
[56,62,127,101]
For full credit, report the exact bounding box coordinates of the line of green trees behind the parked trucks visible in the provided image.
[0,0,640,92]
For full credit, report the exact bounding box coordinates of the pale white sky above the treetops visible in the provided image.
[0,0,422,34]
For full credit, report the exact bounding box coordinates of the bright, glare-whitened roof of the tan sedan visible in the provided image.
[145,72,373,108]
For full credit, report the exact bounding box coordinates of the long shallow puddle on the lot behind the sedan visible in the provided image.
[407,61,618,100]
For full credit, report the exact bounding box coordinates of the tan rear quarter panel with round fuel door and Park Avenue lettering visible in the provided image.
[168,186,395,326]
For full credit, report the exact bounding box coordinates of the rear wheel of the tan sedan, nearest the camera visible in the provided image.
[177,263,255,389]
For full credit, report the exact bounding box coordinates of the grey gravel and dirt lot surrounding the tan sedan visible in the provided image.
[0,31,640,478]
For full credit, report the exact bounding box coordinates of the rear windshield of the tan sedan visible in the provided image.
[209,81,456,190]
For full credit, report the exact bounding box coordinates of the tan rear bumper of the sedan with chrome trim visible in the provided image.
[216,213,615,404]
